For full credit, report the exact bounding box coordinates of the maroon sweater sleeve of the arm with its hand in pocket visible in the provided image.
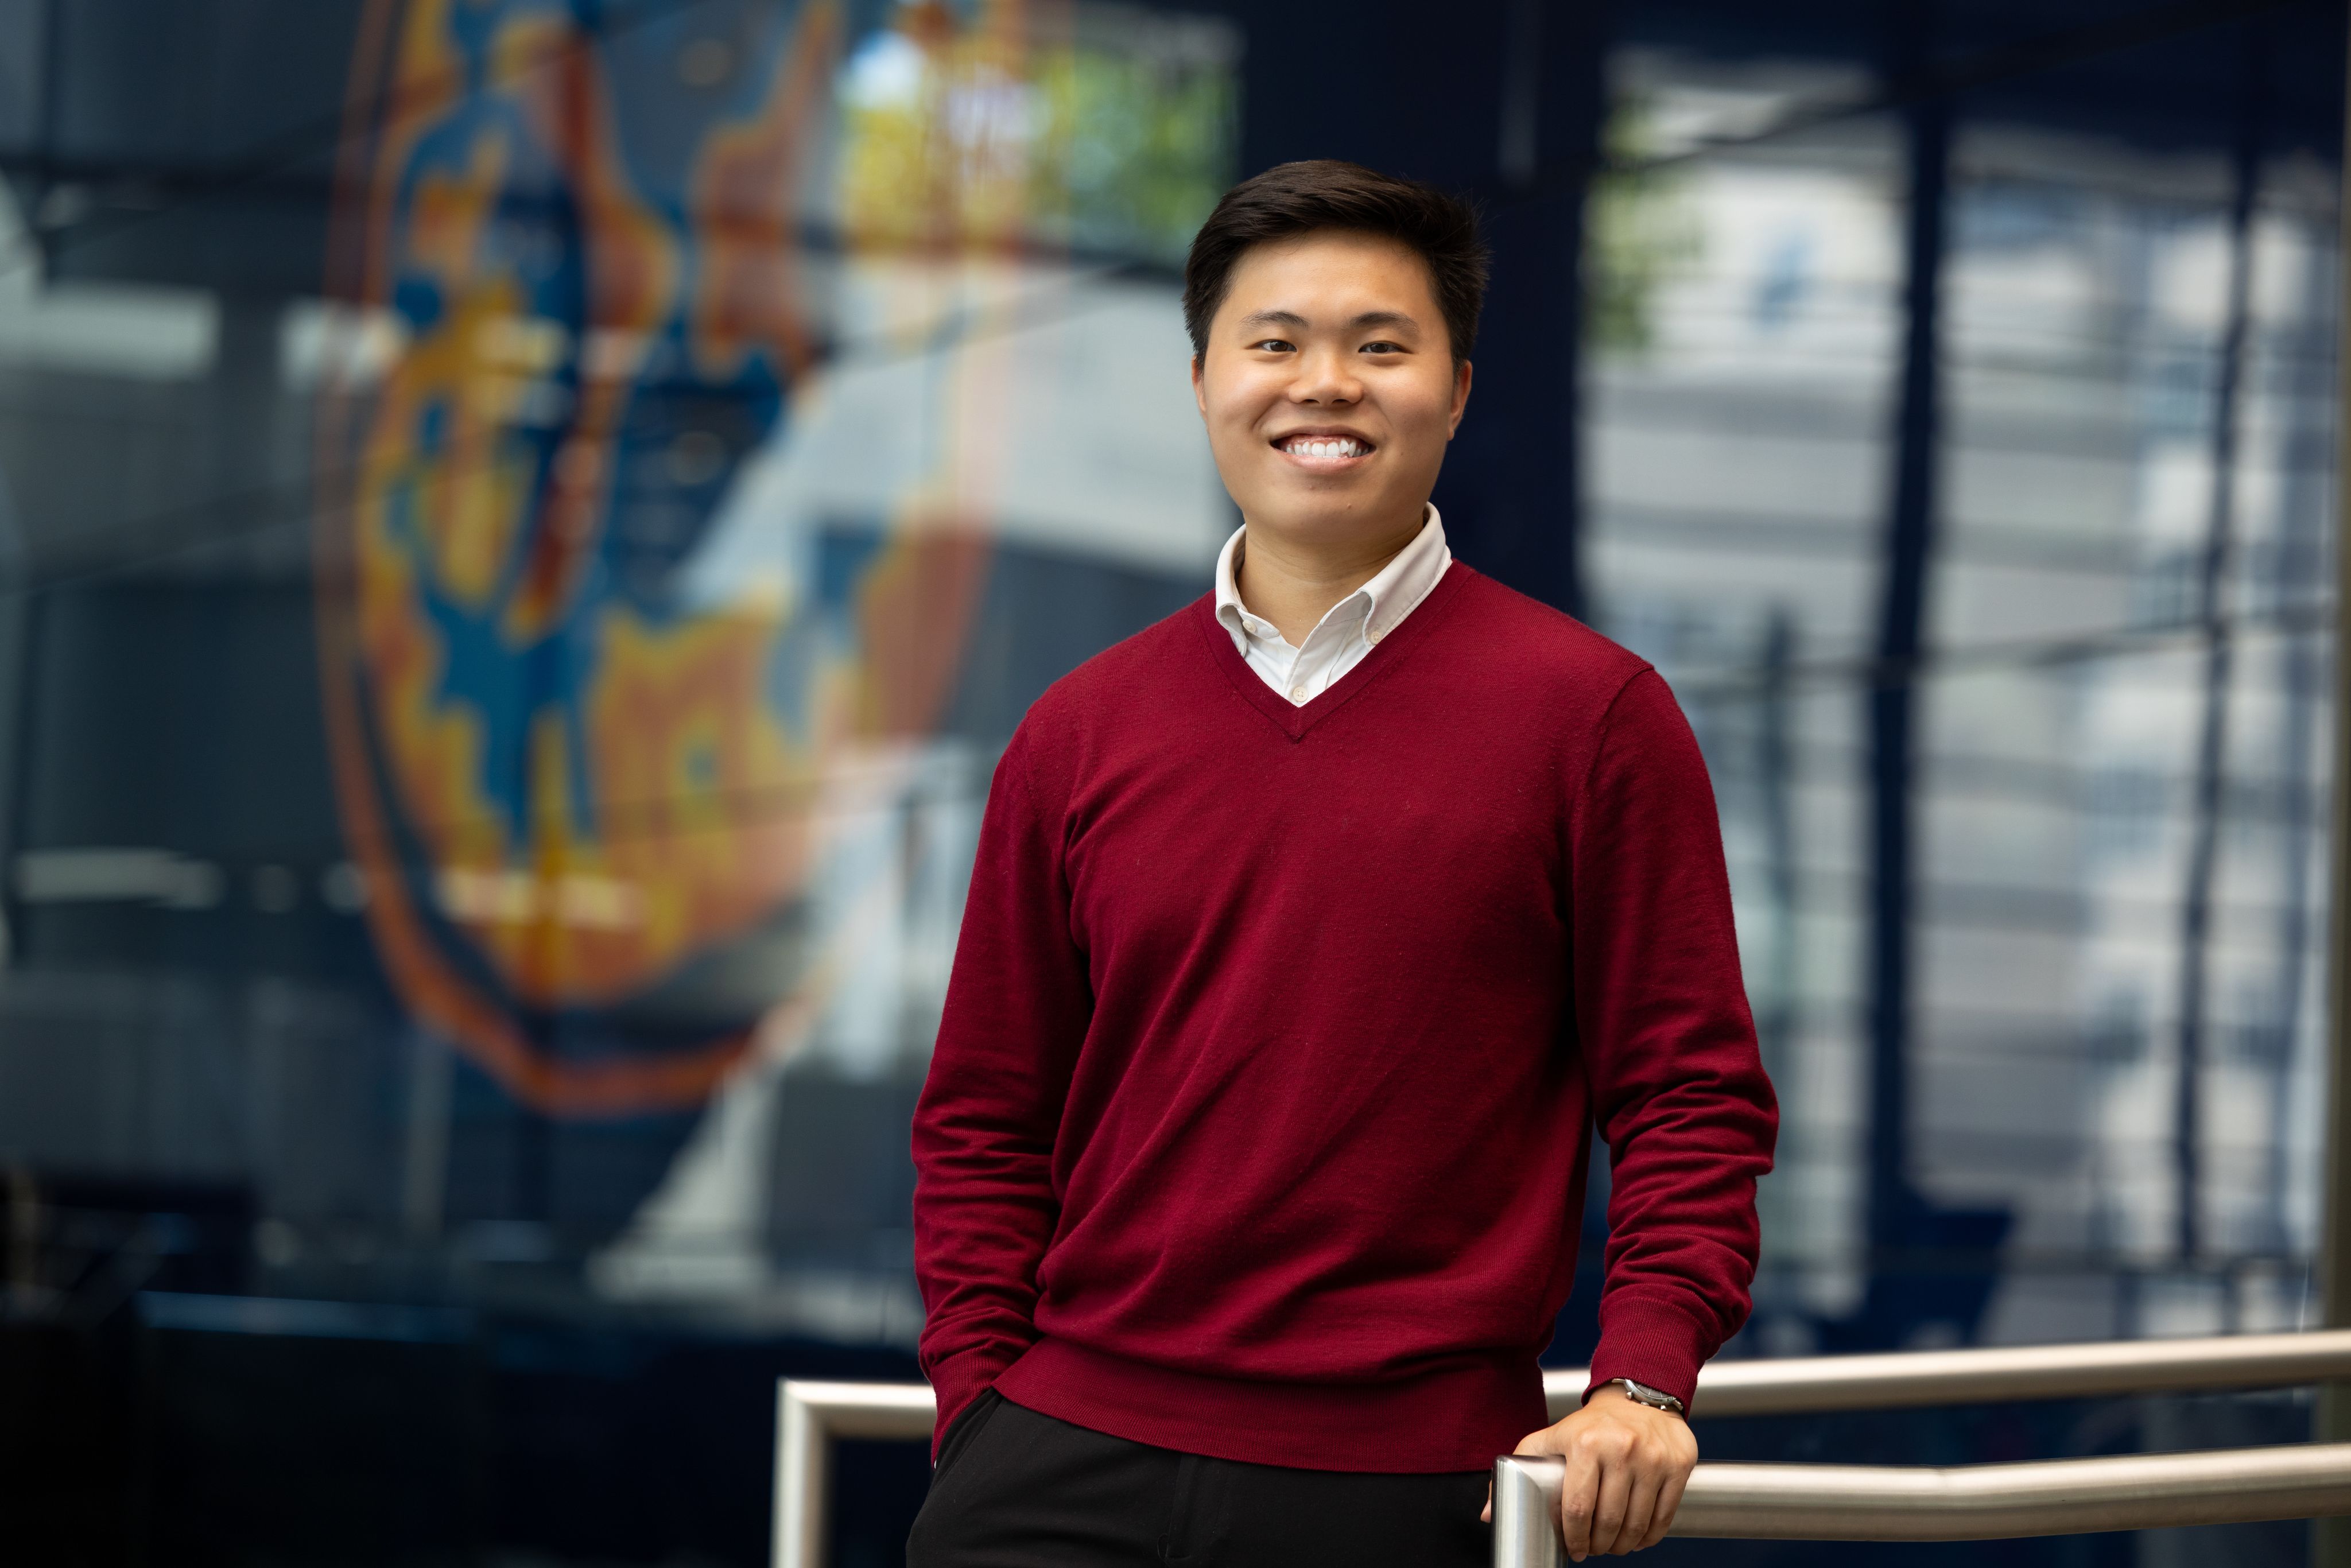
[914,724,1093,1453]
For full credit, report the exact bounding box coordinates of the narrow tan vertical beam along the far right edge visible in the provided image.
[2311,6,2351,1568]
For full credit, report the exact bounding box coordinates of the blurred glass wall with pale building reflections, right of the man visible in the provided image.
[1587,28,2340,1352]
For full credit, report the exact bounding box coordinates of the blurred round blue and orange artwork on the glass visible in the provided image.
[315,0,990,1114]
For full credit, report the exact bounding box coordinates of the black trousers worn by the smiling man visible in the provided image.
[905,1390,1493,1568]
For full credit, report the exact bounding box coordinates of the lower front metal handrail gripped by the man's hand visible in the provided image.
[1493,1443,2351,1568]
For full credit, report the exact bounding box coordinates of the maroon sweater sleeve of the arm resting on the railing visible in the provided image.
[1570,670,1780,1403]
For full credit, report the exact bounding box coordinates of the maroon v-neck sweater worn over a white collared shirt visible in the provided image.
[914,562,1778,1472]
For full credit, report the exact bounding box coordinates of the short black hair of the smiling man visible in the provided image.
[1182,157,1486,362]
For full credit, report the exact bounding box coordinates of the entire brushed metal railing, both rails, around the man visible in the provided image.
[774,1330,2351,1568]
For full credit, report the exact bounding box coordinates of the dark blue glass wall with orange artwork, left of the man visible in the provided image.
[0,0,1242,1561]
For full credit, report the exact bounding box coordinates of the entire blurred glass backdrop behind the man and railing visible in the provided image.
[0,0,2344,1568]
